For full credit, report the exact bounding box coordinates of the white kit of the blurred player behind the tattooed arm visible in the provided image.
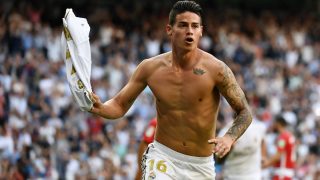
[218,119,267,180]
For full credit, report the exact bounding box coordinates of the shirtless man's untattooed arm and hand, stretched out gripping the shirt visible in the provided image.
[90,60,148,119]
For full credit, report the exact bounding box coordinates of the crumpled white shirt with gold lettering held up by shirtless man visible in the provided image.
[61,9,93,111]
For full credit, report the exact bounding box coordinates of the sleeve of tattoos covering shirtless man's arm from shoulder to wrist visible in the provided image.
[218,65,252,141]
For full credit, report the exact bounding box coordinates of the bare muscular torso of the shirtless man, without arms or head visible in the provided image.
[143,50,220,156]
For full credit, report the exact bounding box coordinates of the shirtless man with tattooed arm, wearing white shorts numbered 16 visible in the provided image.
[91,1,252,180]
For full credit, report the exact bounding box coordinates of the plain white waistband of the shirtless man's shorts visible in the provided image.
[152,141,214,164]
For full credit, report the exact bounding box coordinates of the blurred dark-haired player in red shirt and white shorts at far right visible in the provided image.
[263,116,296,180]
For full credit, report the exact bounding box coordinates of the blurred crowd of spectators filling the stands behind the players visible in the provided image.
[0,0,320,179]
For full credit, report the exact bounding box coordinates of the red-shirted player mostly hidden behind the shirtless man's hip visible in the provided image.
[135,118,157,180]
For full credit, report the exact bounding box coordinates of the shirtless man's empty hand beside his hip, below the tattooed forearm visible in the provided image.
[208,135,234,158]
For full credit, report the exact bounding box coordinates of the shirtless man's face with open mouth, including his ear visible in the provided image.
[167,12,202,50]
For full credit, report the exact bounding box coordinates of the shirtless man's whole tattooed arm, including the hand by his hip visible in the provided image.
[209,62,252,157]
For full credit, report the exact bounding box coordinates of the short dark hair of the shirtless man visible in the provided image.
[169,1,202,25]
